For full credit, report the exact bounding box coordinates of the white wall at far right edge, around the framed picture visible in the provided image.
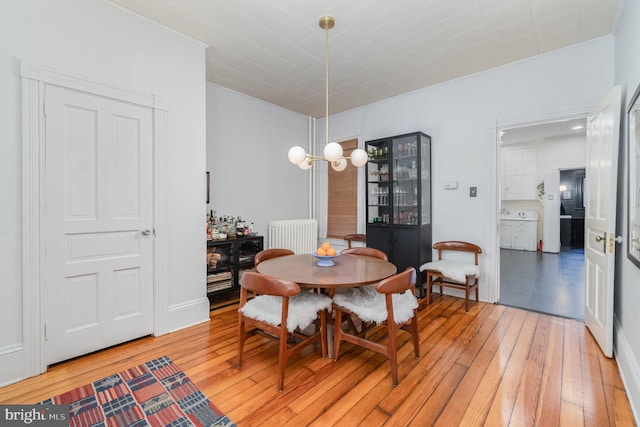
[614,0,640,423]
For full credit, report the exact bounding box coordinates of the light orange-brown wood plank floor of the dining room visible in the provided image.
[0,297,635,427]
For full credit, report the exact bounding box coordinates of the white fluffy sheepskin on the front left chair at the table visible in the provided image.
[240,291,331,332]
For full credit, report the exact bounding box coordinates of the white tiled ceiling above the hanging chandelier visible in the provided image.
[109,0,624,117]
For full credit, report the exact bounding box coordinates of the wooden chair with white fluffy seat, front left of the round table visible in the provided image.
[238,272,331,391]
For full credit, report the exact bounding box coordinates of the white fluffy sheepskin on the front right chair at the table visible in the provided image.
[333,285,418,324]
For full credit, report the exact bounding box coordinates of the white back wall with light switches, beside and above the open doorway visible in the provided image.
[317,37,614,301]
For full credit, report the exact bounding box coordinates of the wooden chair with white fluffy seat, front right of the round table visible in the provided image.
[333,267,420,386]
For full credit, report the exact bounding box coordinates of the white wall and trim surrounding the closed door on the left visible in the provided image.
[0,0,208,384]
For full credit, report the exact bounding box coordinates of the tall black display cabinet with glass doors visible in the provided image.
[366,132,432,294]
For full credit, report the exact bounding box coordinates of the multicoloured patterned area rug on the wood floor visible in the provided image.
[41,356,235,427]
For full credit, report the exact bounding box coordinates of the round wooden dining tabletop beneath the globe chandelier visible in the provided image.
[256,254,397,296]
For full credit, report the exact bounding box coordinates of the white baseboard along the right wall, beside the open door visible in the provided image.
[613,316,640,425]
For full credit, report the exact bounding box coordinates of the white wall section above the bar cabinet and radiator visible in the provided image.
[206,83,311,247]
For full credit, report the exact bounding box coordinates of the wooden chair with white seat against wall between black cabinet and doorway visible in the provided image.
[420,240,482,311]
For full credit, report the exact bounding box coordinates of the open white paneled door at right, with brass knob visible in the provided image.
[584,86,621,357]
